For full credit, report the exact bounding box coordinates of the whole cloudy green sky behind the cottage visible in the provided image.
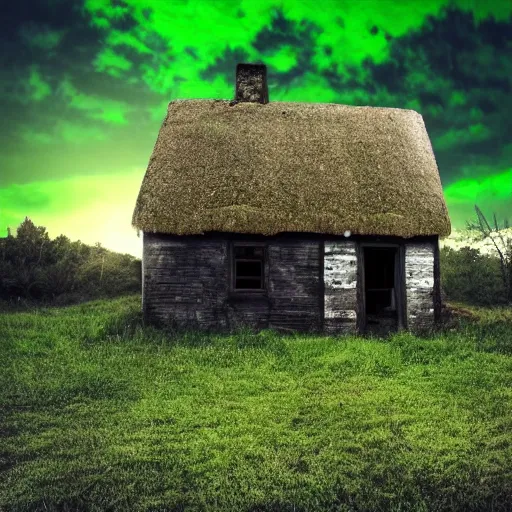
[0,0,512,257]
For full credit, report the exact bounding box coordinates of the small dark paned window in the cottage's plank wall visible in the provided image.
[233,243,265,291]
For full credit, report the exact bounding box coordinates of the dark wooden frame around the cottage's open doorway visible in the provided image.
[357,242,407,334]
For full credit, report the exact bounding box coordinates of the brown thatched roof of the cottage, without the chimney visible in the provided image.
[132,100,450,237]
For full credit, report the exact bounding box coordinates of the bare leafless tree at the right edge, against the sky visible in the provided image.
[467,204,512,304]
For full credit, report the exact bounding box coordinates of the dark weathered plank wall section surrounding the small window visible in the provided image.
[143,234,322,331]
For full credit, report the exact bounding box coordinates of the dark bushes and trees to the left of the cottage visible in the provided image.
[0,217,141,304]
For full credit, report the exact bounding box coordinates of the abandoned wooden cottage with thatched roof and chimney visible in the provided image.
[132,64,450,333]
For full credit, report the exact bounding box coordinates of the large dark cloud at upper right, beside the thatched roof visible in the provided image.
[363,9,512,183]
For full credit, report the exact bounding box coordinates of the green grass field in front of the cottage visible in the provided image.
[0,296,512,512]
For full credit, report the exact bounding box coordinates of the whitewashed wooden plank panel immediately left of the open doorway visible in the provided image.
[324,240,358,333]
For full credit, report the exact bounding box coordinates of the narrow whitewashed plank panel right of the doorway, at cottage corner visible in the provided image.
[405,242,435,331]
